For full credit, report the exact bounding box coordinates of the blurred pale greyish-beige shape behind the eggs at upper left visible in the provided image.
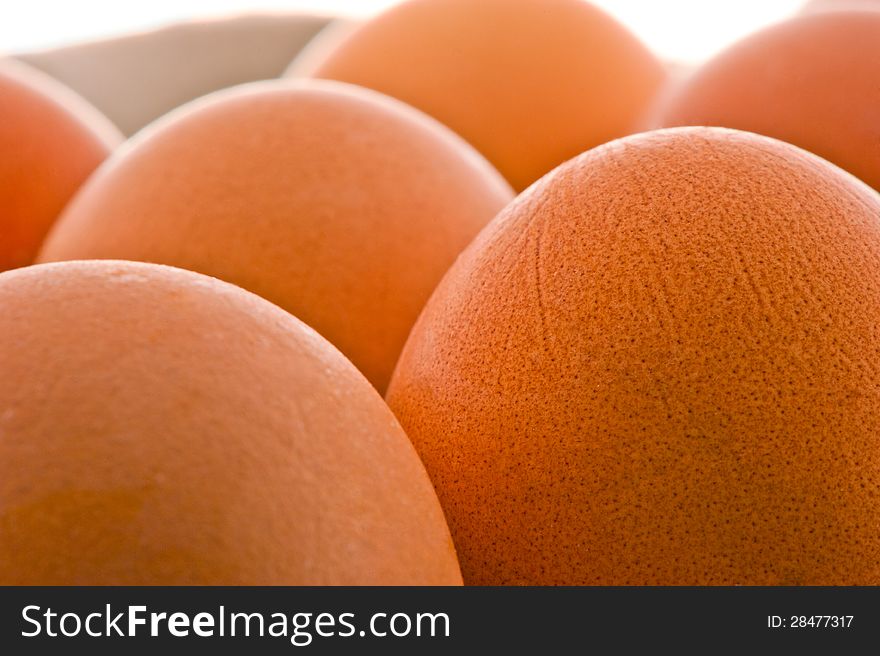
[18,14,330,134]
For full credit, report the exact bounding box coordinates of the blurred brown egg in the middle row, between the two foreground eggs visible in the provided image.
[40,81,512,390]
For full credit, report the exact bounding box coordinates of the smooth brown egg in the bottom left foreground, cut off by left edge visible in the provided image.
[0,262,461,585]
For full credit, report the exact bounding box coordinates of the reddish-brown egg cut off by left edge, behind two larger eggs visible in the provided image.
[0,60,122,271]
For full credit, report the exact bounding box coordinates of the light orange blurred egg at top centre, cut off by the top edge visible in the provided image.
[296,0,664,189]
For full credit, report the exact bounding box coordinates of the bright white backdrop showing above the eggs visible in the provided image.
[0,0,803,62]
